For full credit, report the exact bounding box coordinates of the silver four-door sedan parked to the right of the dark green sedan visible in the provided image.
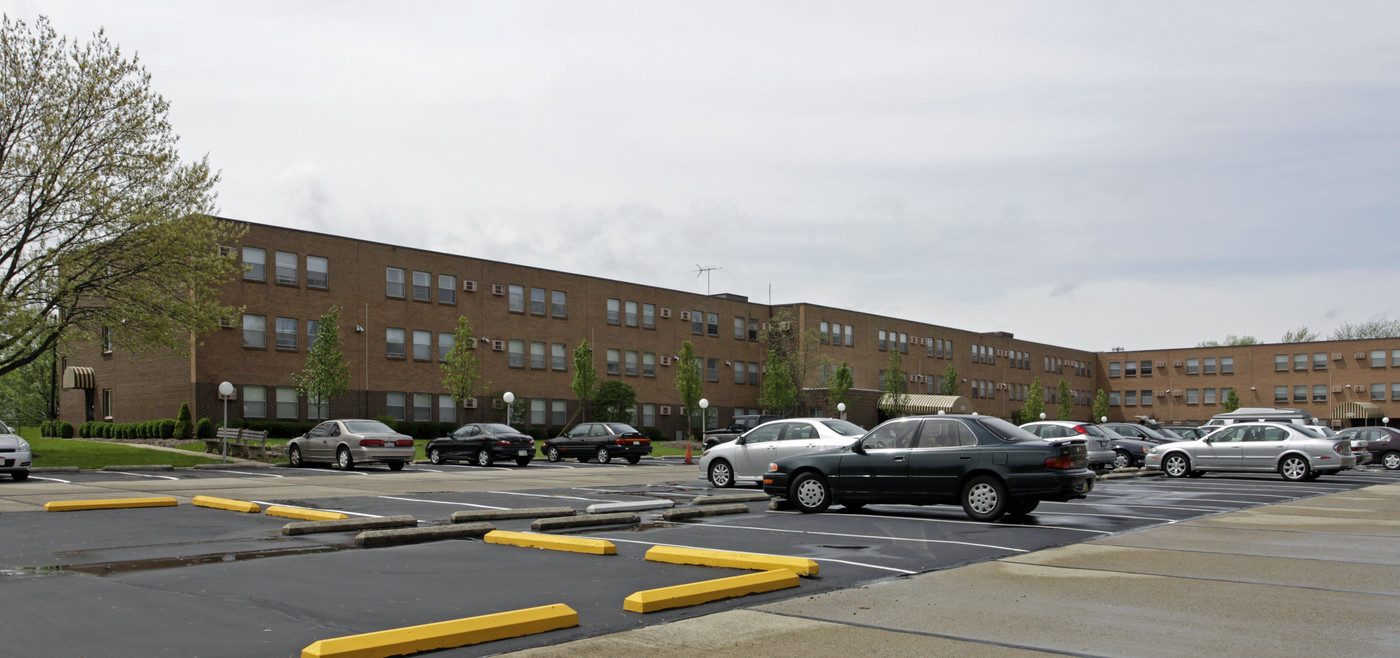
[1147,423,1357,482]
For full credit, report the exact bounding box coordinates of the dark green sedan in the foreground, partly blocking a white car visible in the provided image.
[763,416,1093,521]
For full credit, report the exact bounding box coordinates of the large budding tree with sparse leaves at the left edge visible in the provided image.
[0,17,244,375]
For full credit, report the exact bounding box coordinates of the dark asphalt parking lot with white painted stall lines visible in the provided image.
[0,459,1400,655]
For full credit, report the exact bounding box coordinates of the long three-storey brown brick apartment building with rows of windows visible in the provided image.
[60,220,1400,435]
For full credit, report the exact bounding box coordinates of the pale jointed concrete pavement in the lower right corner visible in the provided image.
[511,484,1400,658]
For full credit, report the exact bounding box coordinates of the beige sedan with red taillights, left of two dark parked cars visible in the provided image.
[287,419,414,470]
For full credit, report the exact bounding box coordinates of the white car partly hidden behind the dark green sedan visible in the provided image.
[700,419,865,487]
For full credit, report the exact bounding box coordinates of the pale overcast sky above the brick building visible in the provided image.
[19,0,1400,351]
